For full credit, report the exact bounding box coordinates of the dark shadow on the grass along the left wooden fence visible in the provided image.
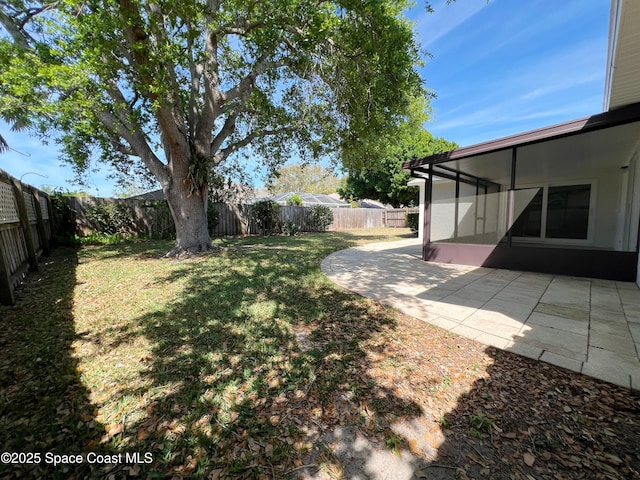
[0,248,108,478]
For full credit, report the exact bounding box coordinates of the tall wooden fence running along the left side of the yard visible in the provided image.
[0,170,53,305]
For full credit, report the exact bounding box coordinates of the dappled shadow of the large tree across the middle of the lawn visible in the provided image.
[79,237,436,478]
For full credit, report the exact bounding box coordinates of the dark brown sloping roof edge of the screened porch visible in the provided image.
[402,102,640,171]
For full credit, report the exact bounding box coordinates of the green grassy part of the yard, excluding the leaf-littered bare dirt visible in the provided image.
[0,230,412,478]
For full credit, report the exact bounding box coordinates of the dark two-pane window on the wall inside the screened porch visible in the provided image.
[511,183,592,244]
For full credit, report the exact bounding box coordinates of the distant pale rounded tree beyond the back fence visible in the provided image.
[267,163,340,194]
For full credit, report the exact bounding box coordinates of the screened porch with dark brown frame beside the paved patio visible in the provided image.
[404,103,640,281]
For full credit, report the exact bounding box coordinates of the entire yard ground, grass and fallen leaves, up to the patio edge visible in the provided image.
[0,229,640,480]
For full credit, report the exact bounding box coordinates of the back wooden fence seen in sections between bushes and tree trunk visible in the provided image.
[68,197,417,237]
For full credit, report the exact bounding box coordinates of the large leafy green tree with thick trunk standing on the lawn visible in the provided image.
[0,0,426,253]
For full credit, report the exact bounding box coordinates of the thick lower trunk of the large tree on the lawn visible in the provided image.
[165,181,212,257]
